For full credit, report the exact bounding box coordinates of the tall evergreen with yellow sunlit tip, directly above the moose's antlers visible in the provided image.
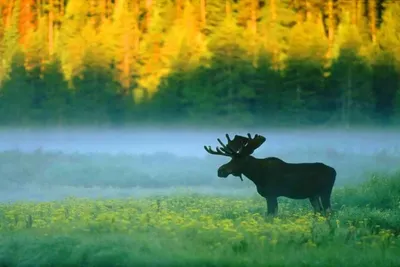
[188,13,255,125]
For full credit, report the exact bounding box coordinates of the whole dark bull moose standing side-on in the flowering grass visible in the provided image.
[204,134,336,216]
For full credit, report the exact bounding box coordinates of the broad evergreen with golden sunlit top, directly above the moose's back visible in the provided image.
[284,11,330,125]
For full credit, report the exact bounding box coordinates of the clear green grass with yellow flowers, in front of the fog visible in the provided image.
[0,173,400,267]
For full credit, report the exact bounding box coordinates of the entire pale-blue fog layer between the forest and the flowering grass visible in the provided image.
[0,128,400,201]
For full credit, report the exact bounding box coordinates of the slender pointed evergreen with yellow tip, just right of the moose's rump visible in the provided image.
[329,11,373,127]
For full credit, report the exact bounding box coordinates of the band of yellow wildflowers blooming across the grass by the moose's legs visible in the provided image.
[0,197,399,248]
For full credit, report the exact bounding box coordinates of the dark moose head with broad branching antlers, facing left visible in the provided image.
[204,134,266,181]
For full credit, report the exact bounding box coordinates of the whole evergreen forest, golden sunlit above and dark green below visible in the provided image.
[0,0,400,127]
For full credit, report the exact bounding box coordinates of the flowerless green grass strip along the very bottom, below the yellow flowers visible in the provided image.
[0,233,400,267]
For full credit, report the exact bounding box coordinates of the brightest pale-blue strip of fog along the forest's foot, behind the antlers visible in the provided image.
[0,129,400,157]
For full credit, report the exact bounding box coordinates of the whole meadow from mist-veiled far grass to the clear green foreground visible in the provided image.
[0,129,400,266]
